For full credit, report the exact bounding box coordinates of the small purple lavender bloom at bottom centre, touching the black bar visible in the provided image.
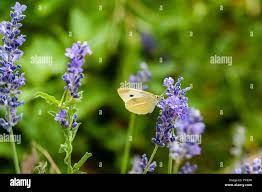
[129,154,157,174]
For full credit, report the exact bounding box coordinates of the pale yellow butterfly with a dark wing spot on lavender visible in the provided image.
[117,88,160,115]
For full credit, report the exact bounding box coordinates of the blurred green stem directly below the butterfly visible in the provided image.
[121,113,136,174]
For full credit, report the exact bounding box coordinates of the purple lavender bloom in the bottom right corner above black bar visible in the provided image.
[235,158,262,174]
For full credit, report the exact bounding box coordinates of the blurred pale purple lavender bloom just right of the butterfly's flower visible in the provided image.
[169,108,205,159]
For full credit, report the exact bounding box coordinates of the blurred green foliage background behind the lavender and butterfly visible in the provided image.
[0,0,262,173]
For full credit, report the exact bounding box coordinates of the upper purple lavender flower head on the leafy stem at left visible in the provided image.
[63,42,92,98]
